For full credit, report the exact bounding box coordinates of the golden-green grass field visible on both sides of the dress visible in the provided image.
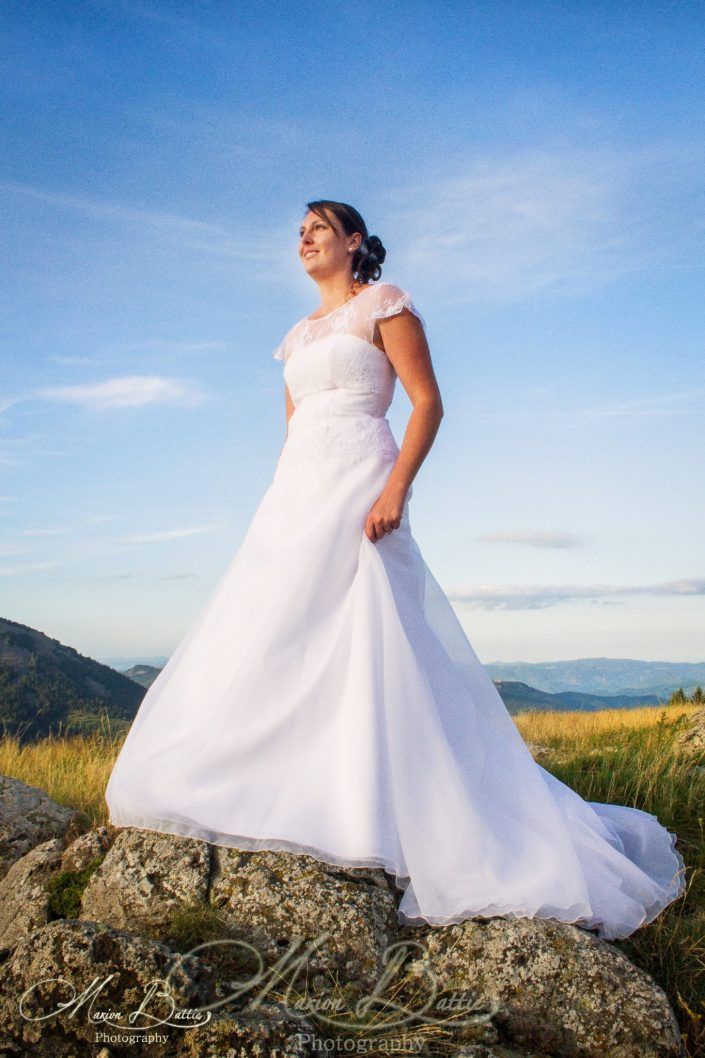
[0,705,705,1058]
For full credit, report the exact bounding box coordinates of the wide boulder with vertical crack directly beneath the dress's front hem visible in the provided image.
[79,827,396,989]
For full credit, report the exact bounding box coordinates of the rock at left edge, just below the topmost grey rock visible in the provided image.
[0,838,64,951]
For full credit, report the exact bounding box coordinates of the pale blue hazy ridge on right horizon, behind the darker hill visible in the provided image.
[485,658,705,701]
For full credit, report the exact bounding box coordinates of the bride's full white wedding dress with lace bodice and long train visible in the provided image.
[106,282,685,938]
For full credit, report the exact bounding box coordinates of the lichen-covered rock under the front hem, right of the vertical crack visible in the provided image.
[210,846,397,992]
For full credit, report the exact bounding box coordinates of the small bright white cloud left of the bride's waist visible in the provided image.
[36,375,206,408]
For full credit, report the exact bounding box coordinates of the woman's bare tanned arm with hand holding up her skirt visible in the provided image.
[365,310,444,542]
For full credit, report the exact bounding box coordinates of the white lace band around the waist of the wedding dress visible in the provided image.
[277,412,399,467]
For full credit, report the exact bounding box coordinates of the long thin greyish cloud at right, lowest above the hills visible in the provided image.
[447,577,705,609]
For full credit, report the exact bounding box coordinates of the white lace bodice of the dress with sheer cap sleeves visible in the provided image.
[268,282,426,462]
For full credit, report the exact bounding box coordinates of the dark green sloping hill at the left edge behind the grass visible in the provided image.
[0,618,145,742]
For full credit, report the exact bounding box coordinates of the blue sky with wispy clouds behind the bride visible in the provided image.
[0,0,705,663]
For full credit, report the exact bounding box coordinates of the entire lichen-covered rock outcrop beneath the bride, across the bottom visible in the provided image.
[0,812,684,1058]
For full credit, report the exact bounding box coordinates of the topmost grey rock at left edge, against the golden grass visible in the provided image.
[0,776,90,877]
